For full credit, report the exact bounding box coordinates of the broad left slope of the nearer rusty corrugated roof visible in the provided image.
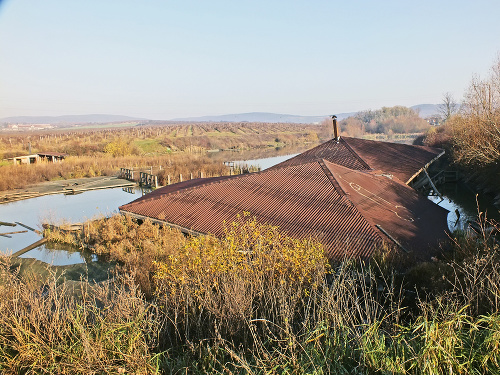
[120,162,382,259]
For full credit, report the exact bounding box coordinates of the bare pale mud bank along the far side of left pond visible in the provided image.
[0,176,136,204]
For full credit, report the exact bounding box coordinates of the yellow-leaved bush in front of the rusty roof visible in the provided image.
[154,214,329,339]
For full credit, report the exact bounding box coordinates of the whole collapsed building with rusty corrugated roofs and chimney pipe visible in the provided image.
[119,119,448,260]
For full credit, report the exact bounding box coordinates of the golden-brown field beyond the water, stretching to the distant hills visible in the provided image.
[0,123,326,191]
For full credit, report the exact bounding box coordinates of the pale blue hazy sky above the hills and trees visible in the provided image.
[0,0,500,119]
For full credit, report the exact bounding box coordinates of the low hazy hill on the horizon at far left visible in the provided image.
[0,114,148,125]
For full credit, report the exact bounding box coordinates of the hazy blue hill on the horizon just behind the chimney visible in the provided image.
[171,112,355,124]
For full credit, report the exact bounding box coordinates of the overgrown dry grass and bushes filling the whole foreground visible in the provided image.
[0,215,500,374]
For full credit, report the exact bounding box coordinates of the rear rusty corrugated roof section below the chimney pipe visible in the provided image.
[272,137,442,182]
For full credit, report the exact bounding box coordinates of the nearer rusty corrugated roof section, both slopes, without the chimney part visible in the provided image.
[120,154,446,259]
